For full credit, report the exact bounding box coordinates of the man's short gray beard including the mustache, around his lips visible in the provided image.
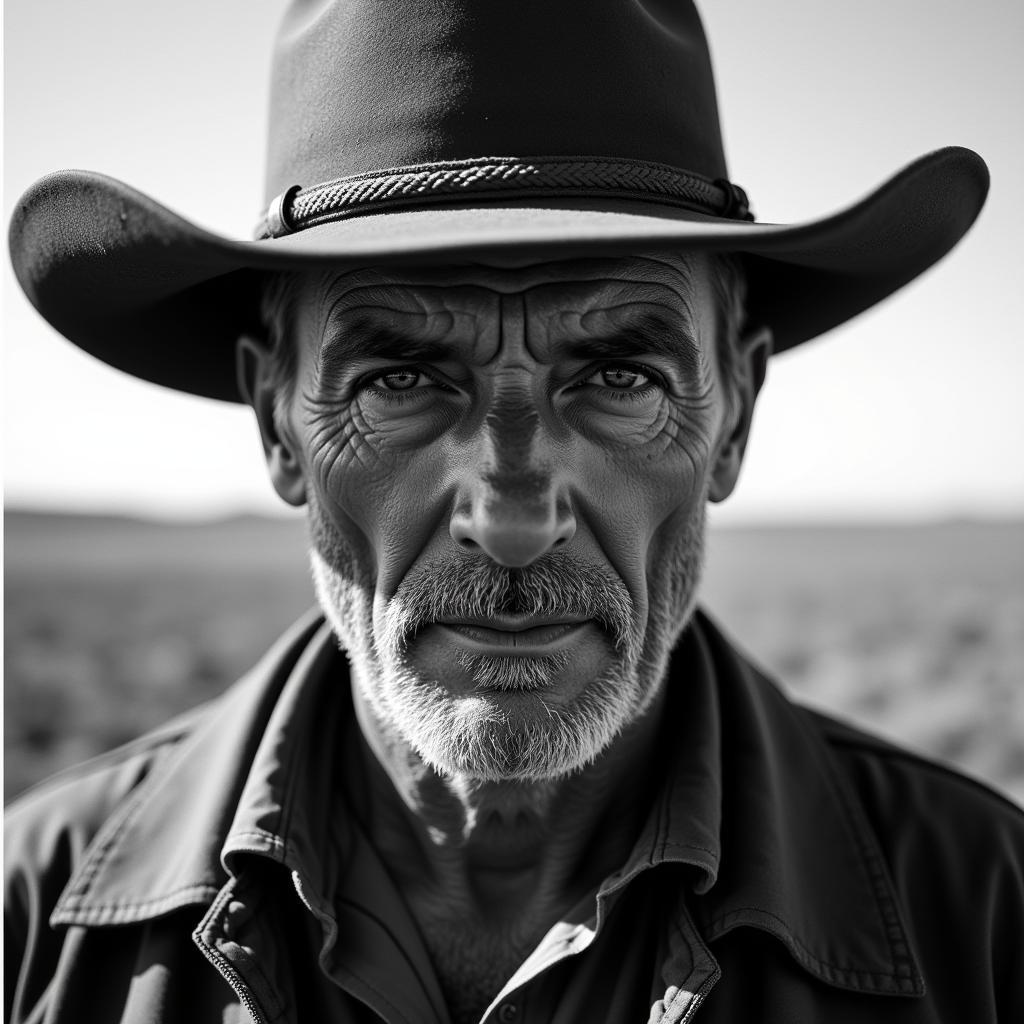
[310,493,705,781]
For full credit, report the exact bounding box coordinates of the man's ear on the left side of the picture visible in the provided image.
[234,335,306,508]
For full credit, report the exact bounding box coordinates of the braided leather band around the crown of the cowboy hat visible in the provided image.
[256,157,754,239]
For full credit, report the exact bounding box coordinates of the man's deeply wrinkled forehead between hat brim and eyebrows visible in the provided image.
[288,254,714,362]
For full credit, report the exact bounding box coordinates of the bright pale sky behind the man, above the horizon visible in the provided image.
[3,0,1024,522]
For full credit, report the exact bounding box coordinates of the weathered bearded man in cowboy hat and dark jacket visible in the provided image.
[7,0,1024,1024]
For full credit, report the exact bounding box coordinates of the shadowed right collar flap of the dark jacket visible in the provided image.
[679,615,925,995]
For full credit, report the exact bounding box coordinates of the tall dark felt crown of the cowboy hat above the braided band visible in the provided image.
[266,0,727,200]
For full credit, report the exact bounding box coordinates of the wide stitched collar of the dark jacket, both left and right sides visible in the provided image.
[51,613,923,995]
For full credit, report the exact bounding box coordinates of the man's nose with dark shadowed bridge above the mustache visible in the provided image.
[450,411,577,568]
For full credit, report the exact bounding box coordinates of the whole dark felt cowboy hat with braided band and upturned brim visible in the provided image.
[10,0,988,400]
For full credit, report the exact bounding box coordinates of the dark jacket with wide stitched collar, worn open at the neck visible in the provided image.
[5,614,1024,1024]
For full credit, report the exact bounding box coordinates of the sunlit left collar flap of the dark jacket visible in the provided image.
[50,613,334,926]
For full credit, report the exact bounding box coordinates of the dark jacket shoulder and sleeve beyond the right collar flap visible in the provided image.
[808,713,1024,1020]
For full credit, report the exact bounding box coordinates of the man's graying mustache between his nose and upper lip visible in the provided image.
[385,552,636,653]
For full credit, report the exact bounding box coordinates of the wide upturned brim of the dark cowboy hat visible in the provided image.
[10,147,988,401]
